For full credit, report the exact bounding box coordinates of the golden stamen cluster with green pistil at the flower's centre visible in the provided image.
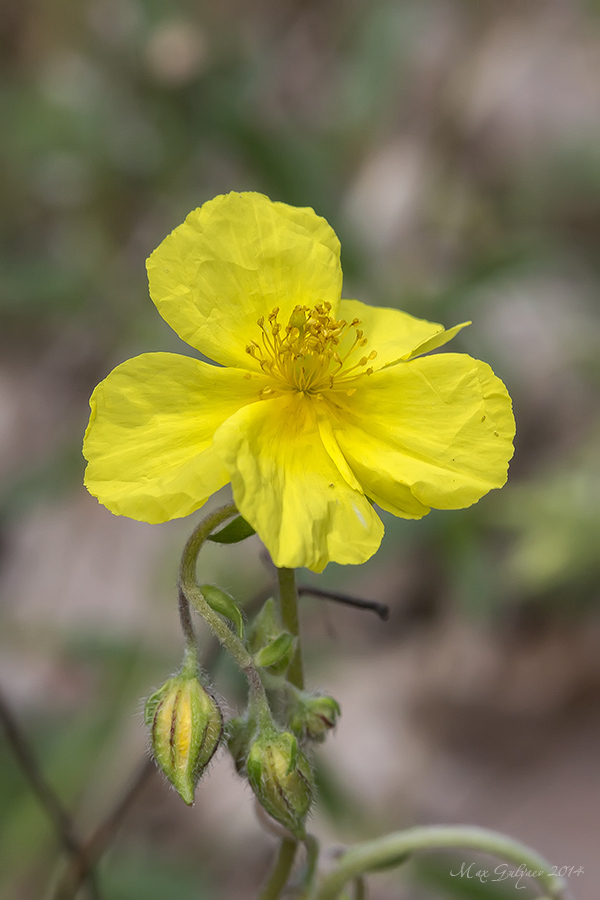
[246,303,377,399]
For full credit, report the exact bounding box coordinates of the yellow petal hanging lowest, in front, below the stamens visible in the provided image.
[215,393,383,572]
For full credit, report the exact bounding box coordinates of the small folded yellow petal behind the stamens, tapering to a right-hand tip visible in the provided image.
[338,300,471,370]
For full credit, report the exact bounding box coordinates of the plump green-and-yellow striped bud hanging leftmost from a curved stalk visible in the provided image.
[145,672,223,806]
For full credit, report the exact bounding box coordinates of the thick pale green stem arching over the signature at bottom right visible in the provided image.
[312,825,567,900]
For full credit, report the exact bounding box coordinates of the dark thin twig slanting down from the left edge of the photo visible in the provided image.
[0,692,100,900]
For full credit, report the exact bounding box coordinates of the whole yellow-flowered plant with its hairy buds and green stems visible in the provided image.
[78,193,564,900]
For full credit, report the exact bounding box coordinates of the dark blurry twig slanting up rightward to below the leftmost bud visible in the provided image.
[54,758,156,900]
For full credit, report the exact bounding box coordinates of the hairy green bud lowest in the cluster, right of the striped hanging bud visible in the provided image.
[246,731,314,840]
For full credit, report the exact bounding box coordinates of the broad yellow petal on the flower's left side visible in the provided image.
[83,353,262,522]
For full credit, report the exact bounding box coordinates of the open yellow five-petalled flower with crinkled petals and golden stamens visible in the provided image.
[84,193,514,572]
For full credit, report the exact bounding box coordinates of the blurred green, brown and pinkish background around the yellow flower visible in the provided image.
[0,0,600,900]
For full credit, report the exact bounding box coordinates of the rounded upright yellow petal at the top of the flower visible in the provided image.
[147,193,342,368]
